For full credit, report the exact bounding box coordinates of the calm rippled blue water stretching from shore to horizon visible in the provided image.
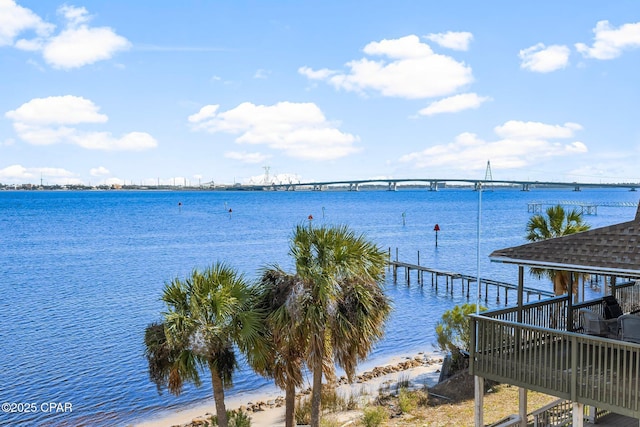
[0,189,638,426]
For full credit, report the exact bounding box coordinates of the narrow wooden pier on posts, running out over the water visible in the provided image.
[389,255,555,305]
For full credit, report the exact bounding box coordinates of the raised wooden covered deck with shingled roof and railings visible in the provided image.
[470,202,640,426]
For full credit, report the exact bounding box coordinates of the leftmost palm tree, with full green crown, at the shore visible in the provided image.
[145,263,265,427]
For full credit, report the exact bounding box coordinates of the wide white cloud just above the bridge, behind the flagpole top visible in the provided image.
[399,121,588,172]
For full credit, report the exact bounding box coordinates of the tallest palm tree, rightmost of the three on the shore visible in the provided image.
[289,224,391,427]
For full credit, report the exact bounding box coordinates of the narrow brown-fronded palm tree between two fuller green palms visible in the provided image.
[254,266,308,427]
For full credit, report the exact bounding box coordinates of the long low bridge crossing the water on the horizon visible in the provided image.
[233,178,640,191]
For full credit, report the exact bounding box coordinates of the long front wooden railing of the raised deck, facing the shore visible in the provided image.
[469,315,640,418]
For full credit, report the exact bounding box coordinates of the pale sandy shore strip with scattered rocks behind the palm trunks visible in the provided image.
[136,351,443,427]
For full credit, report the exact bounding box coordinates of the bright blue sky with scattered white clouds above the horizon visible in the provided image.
[0,0,640,185]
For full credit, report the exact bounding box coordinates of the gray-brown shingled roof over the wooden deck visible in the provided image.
[489,206,640,277]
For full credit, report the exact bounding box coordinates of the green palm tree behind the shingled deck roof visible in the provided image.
[527,205,591,295]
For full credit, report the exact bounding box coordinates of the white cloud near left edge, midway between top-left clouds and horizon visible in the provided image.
[5,95,158,151]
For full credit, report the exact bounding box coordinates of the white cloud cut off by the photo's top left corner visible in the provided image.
[0,0,55,46]
